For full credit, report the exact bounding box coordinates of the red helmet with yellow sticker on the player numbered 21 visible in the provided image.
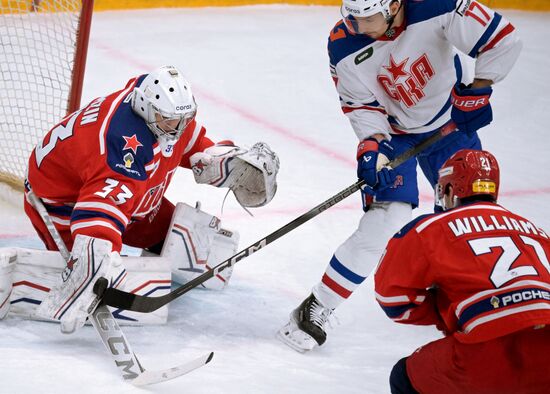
[437,149,500,209]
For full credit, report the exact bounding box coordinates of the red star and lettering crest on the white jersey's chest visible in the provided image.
[377,53,435,107]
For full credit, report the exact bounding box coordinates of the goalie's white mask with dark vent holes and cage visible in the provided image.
[132,66,197,156]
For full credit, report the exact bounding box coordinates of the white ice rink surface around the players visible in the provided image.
[0,6,550,394]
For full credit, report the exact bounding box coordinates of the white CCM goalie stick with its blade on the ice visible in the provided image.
[26,186,214,386]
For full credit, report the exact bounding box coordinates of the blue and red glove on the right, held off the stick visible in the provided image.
[451,83,493,133]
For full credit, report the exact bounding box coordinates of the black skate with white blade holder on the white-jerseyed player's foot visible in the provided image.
[278,294,332,353]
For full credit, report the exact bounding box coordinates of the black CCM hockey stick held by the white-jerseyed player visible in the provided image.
[102,123,456,312]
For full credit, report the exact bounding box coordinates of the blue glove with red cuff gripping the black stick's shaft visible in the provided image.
[357,138,395,194]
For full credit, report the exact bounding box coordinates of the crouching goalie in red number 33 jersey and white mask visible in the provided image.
[21,66,279,331]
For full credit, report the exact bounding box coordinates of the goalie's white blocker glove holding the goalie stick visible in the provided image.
[34,235,125,334]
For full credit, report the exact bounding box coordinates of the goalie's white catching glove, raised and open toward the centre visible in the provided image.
[190,142,279,208]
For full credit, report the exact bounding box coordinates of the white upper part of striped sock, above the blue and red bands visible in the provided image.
[335,202,412,276]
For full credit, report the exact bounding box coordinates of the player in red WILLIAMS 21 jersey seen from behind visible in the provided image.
[374,150,550,394]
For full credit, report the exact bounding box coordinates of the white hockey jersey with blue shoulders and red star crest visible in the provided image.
[328,0,522,140]
